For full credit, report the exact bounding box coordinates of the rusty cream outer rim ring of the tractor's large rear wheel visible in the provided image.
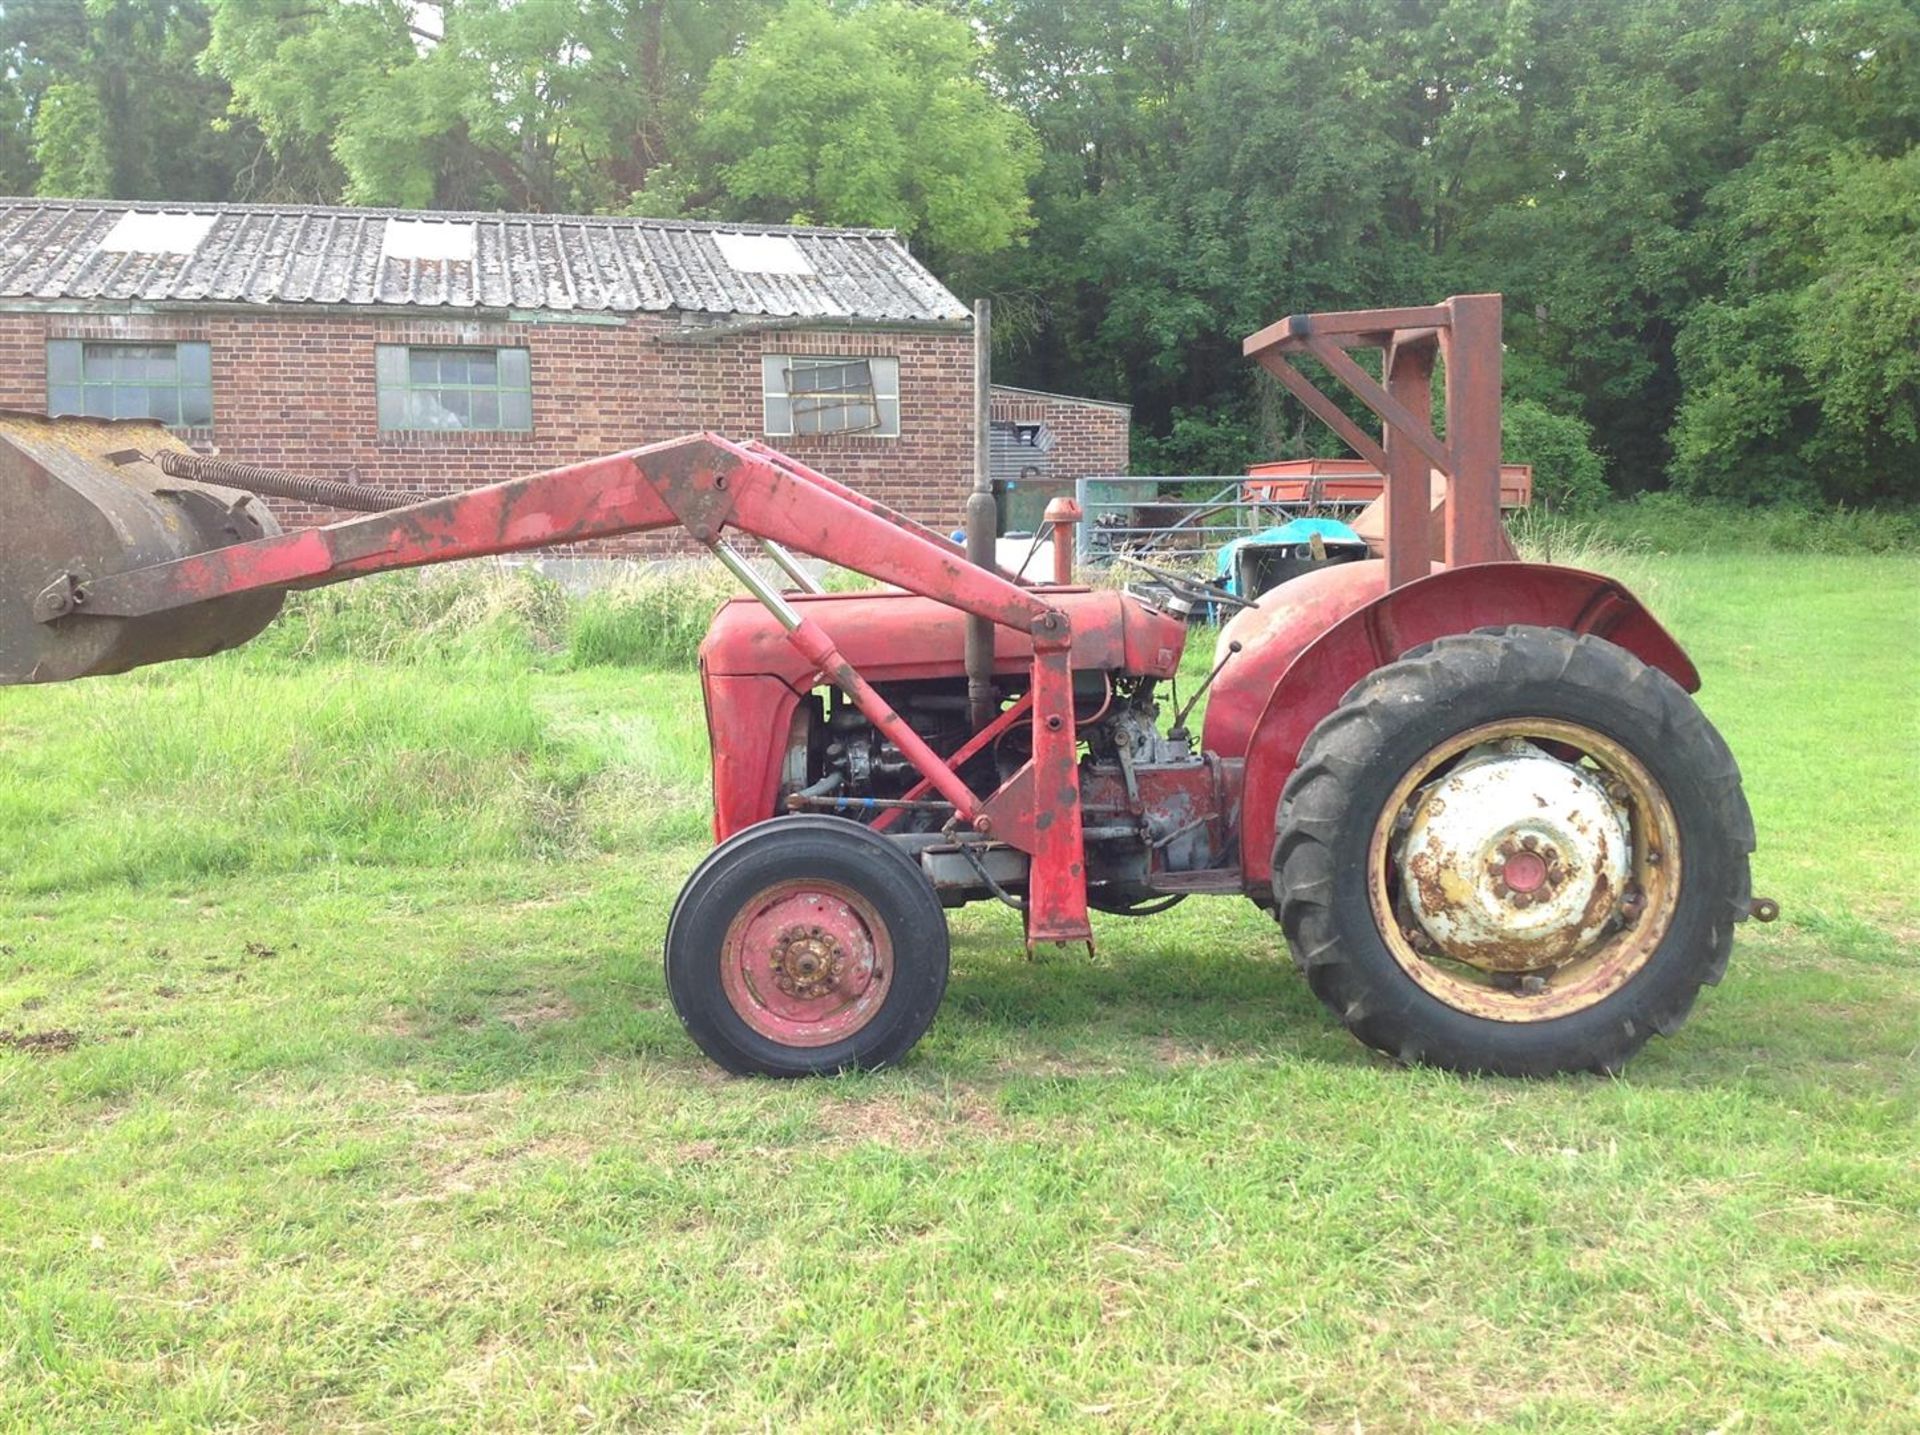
[1367,717,1680,1022]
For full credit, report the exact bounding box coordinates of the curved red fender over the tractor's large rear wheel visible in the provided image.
[1204,561,1699,899]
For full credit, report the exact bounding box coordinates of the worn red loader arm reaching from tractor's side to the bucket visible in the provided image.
[33,432,1091,941]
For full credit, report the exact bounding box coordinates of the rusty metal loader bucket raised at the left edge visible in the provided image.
[0,411,282,684]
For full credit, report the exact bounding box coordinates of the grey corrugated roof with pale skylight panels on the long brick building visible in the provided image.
[0,198,968,323]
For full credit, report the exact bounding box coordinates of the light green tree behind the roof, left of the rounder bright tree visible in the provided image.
[207,0,768,211]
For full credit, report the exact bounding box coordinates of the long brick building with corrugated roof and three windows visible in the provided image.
[0,200,1125,553]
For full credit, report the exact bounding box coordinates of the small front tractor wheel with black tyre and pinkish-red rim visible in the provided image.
[666,815,948,1076]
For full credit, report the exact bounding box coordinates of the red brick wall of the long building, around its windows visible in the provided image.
[0,309,973,555]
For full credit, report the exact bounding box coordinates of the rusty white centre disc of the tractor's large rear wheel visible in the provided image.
[1396,738,1632,972]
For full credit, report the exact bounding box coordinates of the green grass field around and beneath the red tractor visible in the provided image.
[0,555,1920,1431]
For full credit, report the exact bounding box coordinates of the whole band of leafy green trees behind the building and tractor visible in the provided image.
[0,0,1920,501]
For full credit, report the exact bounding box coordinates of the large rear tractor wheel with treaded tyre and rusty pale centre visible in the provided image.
[1273,626,1753,1076]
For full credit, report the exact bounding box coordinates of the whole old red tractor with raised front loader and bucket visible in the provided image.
[0,296,1770,1076]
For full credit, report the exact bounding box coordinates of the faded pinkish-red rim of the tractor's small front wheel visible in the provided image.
[720,878,893,1047]
